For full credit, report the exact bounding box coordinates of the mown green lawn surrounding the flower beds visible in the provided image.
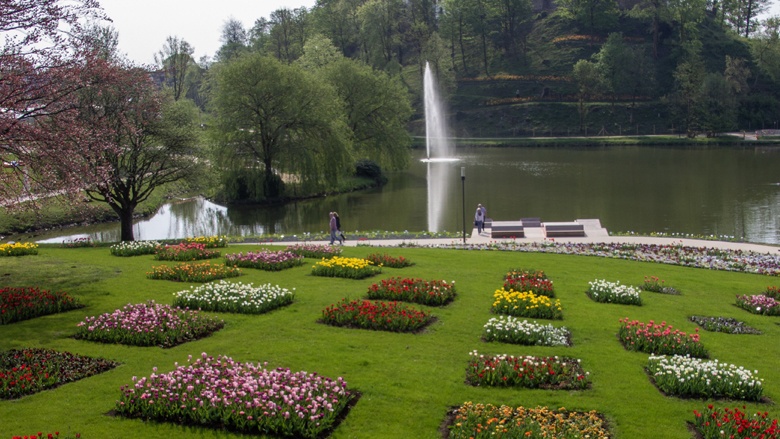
[0,245,780,439]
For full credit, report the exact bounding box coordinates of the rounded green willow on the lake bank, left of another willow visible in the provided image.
[212,53,352,201]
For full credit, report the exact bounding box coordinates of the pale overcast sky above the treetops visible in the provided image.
[99,0,780,64]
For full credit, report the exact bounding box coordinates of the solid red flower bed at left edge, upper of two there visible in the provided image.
[0,287,84,325]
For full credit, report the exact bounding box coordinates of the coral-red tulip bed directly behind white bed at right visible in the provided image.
[618,317,708,358]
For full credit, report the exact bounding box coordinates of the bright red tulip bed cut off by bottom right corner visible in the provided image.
[693,404,780,439]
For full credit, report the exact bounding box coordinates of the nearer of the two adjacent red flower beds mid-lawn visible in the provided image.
[322,299,433,332]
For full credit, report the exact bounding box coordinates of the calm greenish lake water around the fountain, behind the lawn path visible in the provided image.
[36,146,780,244]
